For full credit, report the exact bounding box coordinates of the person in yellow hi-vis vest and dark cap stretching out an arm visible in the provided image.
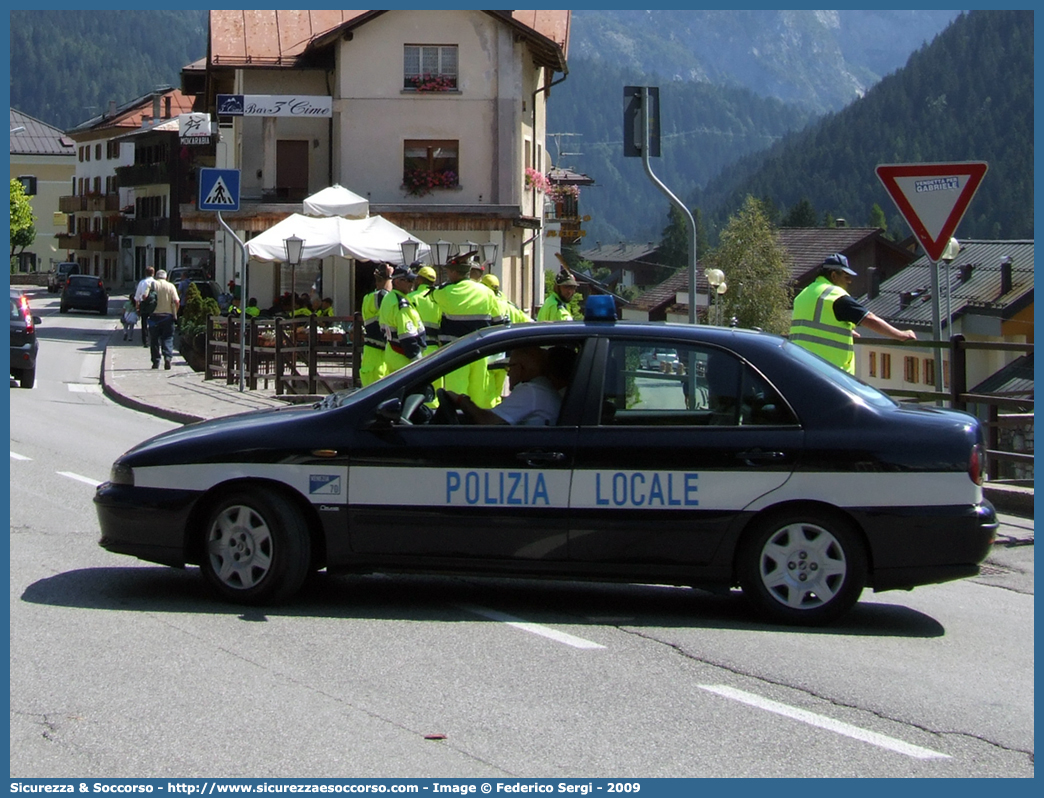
[790,253,917,374]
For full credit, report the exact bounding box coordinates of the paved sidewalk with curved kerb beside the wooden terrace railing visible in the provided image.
[101,329,288,424]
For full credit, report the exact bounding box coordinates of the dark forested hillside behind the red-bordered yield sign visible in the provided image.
[686,11,1034,238]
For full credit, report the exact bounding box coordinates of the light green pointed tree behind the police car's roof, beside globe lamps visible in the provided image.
[708,195,792,334]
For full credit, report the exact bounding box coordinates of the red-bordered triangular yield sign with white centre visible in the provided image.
[876,161,987,261]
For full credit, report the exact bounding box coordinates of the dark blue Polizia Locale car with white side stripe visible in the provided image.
[95,309,997,624]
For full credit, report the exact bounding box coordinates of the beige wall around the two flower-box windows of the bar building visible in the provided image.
[334,10,544,205]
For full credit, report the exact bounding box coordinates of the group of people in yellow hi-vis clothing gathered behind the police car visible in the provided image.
[359,252,577,408]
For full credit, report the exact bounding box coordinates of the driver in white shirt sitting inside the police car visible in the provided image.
[447,347,562,426]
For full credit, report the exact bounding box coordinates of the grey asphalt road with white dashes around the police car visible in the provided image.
[10,290,1034,778]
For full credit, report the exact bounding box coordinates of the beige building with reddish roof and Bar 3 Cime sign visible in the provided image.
[182,10,570,312]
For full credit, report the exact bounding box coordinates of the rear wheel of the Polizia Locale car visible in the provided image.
[737,511,867,626]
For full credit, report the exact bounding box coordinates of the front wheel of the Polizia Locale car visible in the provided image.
[199,489,311,604]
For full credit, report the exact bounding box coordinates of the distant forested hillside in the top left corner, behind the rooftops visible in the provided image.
[9,10,207,130]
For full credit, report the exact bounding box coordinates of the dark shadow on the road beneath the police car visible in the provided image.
[22,566,946,638]
